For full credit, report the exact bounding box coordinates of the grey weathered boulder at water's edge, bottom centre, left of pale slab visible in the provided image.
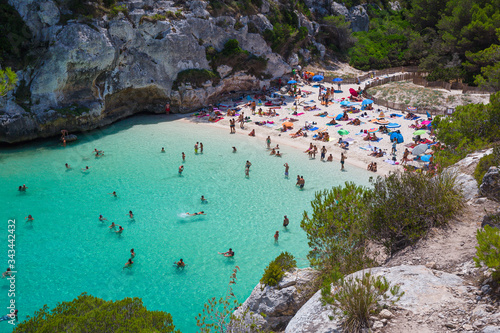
[234,268,318,332]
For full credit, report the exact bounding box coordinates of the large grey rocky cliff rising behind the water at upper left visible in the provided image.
[0,0,368,142]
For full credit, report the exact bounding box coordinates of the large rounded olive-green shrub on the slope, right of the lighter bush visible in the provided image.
[366,172,464,255]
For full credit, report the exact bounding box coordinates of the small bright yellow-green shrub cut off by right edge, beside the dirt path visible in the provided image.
[474,225,500,281]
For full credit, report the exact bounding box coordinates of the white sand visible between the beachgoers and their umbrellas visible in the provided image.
[180,79,428,175]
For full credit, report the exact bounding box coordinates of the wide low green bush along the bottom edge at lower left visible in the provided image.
[14,293,180,333]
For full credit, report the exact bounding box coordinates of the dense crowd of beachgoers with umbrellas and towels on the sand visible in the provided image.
[185,72,440,174]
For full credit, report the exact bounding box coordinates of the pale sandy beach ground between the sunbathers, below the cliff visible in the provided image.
[183,77,429,175]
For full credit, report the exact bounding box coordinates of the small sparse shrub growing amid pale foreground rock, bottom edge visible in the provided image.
[323,272,404,332]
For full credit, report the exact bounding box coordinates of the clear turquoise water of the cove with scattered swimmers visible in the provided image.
[0,116,370,332]
